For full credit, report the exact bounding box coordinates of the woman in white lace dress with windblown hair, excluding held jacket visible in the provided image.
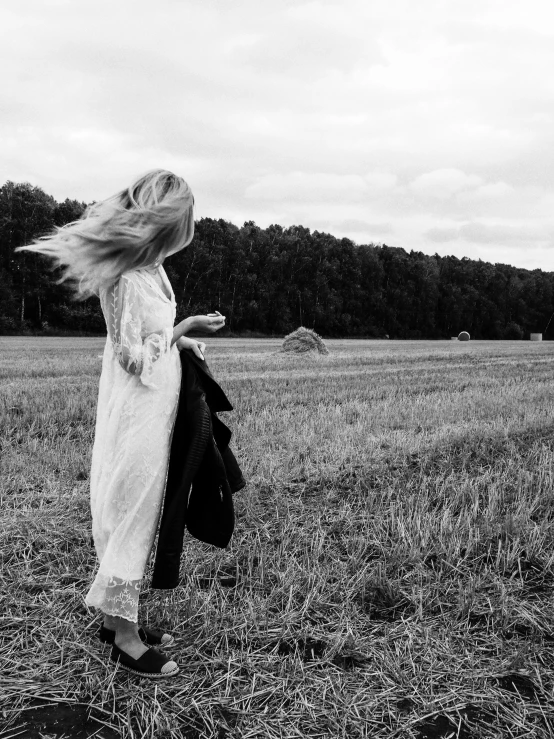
[17,170,225,678]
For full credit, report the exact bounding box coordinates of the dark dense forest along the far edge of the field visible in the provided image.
[0,181,554,339]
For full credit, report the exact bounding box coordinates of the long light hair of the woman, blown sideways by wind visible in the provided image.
[15,169,194,300]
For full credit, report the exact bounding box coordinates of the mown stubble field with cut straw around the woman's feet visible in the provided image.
[0,337,554,739]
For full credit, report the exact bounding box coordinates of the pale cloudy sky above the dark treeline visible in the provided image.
[0,0,554,270]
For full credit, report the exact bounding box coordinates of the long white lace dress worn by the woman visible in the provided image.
[85,267,181,622]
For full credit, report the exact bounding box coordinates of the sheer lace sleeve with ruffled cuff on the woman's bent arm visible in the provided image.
[106,275,173,390]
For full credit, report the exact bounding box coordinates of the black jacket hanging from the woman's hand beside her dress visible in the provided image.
[151,349,246,588]
